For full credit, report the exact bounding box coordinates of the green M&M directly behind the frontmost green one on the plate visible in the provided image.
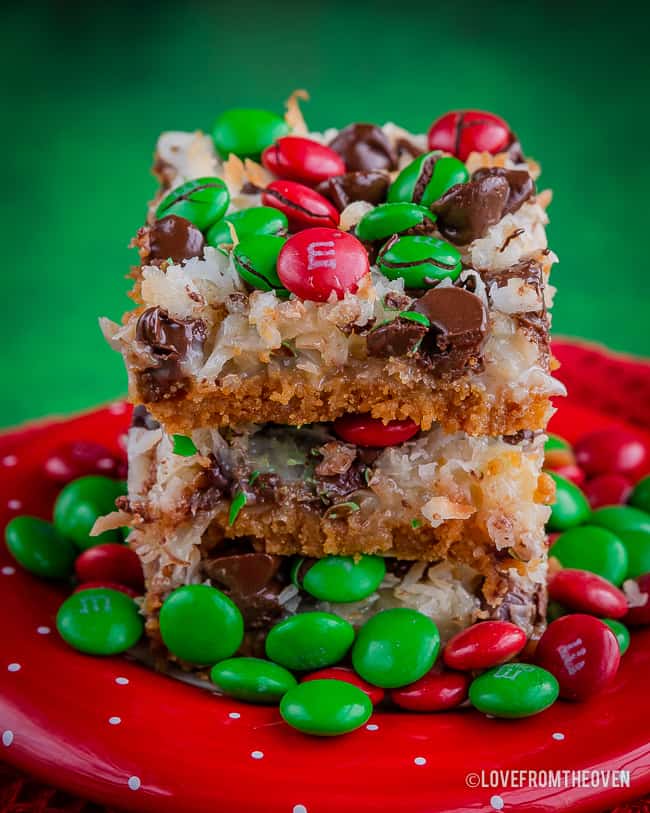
[266,612,354,671]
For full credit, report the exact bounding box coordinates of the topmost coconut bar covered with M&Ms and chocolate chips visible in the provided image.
[103,95,562,435]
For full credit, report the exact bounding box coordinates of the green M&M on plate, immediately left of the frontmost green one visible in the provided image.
[210,658,296,703]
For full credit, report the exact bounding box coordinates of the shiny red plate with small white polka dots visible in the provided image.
[0,344,650,813]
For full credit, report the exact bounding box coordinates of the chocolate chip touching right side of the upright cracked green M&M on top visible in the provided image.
[431,175,510,246]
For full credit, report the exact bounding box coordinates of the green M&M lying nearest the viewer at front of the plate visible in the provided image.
[280,679,372,737]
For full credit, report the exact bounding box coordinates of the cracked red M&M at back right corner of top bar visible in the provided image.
[428,110,513,161]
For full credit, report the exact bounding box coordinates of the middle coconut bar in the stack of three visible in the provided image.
[122,408,553,636]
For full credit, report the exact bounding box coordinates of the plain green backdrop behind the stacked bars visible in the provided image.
[0,0,650,425]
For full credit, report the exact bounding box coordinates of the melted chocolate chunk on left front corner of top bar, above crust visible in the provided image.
[136,307,206,401]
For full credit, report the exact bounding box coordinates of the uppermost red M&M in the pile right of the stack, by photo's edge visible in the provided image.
[574,428,650,480]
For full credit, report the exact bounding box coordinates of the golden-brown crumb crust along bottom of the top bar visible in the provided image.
[137,360,552,435]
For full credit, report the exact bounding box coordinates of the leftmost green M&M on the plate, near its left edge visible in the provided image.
[5,516,78,579]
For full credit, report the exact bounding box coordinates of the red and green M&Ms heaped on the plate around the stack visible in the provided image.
[5,428,650,735]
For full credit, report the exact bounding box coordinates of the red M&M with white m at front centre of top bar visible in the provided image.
[277,229,370,302]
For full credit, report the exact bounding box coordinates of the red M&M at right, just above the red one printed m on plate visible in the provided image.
[548,567,627,618]
